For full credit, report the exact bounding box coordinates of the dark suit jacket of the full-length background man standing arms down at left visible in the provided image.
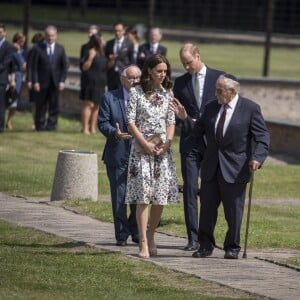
[32,42,69,88]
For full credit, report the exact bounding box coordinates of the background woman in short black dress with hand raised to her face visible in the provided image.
[80,35,107,134]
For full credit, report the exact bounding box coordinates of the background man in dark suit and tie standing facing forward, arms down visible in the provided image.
[32,26,68,131]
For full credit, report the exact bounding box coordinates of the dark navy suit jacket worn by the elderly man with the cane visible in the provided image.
[185,96,270,183]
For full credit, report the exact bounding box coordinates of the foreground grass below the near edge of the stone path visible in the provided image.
[0,220,254,300]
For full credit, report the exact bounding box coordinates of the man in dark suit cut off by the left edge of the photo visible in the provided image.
[0,24,16,133]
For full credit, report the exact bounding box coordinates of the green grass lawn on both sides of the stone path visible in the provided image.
[0,112,300,299]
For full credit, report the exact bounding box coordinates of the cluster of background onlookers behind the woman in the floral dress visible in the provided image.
[80,23,167,134]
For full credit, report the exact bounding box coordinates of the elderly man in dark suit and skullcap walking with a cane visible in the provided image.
[173,74,270,259]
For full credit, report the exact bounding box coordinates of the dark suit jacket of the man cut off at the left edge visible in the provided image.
[0,40,16,85]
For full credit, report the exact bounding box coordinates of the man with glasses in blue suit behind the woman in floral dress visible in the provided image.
[98,65,141,246]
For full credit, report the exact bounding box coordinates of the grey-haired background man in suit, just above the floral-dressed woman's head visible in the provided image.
[137,27,167,69]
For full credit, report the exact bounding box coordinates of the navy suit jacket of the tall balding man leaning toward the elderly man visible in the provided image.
[173,67,224,153]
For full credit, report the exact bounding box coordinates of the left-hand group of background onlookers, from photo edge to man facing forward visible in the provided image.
[0,24,69,132]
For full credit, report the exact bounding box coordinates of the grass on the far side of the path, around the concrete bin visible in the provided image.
[0,112,300,249]
